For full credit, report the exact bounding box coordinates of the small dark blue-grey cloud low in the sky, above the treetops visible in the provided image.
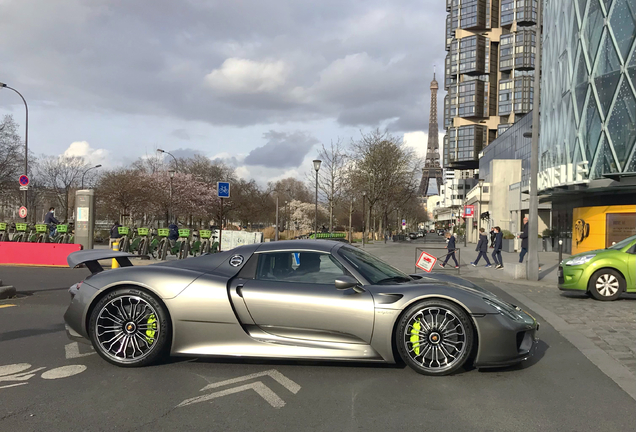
[245,130,319,168]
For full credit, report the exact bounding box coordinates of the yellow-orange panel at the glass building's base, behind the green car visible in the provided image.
[572,205,636,255]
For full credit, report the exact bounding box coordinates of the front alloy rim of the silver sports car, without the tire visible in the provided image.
[403,306,467,372]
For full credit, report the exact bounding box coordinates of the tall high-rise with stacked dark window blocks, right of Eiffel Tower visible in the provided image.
[443,0,537,170]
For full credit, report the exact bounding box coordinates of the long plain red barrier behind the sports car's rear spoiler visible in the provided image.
[0,242,82,267]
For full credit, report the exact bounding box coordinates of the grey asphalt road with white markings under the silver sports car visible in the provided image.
[0,250,636,432]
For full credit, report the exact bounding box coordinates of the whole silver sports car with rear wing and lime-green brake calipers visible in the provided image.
[64,240,539,375]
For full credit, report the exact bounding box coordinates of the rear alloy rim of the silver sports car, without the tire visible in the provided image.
[94,295,161,363]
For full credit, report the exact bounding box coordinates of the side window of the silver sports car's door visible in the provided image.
[256,251,349,284]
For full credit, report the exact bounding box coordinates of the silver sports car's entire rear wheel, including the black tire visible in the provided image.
[88,288,171,367]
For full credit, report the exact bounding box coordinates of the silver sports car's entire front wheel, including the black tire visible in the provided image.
[395,300,474,376]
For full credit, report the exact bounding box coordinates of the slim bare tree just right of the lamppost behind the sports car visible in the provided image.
[312,138,349,232]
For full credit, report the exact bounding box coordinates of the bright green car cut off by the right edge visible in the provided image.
[559,236,636,300]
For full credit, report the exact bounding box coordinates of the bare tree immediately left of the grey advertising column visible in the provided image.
[37,156,88,222]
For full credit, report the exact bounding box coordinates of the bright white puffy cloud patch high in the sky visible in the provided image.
[205,58,288,94]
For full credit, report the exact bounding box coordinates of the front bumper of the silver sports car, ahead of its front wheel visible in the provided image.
[475,312,539,368]
